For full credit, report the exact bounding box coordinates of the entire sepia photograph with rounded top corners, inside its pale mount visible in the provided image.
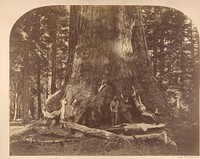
[9,5,199,156]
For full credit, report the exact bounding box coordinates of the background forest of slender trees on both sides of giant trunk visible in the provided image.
[10,6,199,155]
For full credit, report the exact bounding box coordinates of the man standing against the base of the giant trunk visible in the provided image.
[110,96,119,126]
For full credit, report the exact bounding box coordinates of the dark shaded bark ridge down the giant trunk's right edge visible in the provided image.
[132,6,170,113]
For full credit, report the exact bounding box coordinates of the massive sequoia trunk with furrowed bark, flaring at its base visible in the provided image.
[47,6,167,125]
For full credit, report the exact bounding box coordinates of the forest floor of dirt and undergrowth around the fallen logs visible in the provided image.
[10,111,199,156]
